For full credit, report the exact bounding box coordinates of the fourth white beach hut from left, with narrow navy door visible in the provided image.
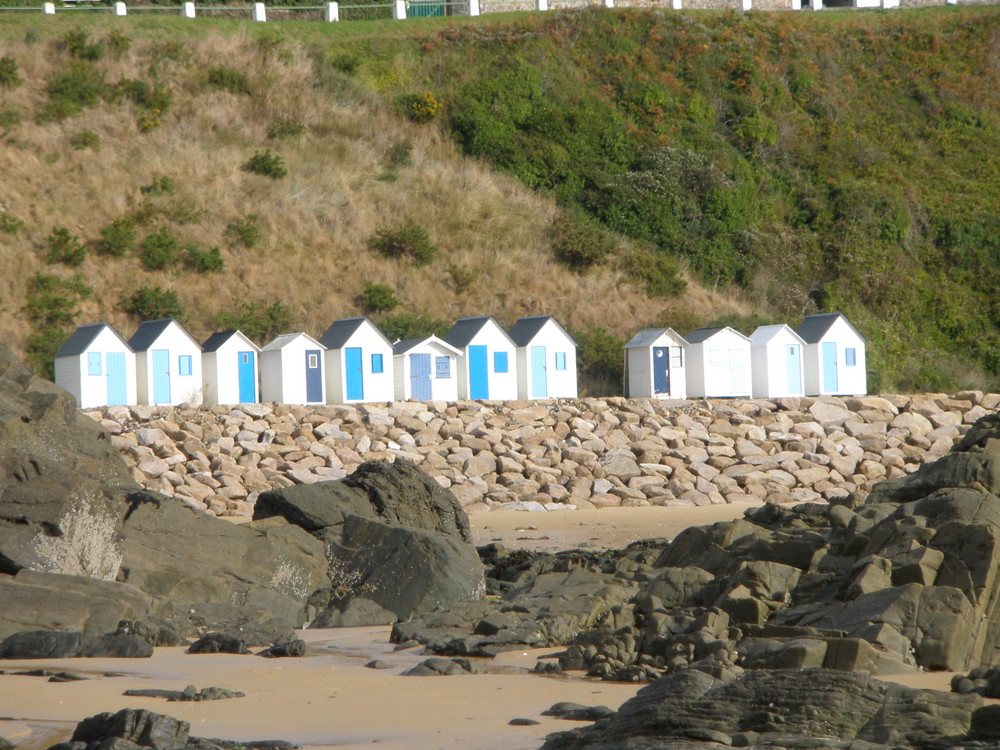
[260,331,326,404]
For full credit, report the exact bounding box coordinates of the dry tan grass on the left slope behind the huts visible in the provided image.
[0,13,751,362]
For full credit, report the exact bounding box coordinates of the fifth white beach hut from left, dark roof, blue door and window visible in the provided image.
[319,317,394,404]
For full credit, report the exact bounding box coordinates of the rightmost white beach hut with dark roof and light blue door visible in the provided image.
[795,313,868,396]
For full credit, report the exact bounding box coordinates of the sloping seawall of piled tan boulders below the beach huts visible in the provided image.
[86,391,1000,516]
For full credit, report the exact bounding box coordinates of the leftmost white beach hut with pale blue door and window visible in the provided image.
[55,323,136,409]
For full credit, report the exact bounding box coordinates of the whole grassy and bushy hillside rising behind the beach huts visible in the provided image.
[0,8,1000,392]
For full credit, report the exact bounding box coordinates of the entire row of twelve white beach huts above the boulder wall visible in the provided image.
[55,313,867,408]
